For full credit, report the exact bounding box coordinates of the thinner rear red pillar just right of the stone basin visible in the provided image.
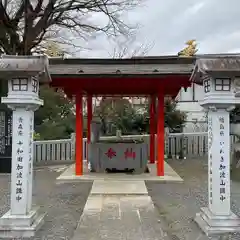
[150,96,156,163]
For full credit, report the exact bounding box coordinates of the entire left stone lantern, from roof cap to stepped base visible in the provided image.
[0,56,50,238]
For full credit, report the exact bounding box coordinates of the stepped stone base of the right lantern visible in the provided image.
[194,207,240,236]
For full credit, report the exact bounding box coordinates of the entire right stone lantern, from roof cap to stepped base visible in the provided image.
[191,55,240,236]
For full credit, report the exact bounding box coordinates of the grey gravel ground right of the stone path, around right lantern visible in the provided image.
[146,159,240,240]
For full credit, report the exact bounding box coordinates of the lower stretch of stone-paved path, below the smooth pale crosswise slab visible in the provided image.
[72,196,170,240]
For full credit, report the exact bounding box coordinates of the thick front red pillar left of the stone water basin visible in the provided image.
[75,93,83,176]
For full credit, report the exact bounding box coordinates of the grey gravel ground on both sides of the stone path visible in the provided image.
[0,159,240,240]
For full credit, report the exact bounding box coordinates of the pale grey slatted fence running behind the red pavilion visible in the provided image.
[34,132,238,165]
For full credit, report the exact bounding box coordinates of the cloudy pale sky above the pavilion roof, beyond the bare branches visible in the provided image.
[76,0,240,58]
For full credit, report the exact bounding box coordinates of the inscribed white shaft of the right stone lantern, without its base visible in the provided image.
[208,108,231,216]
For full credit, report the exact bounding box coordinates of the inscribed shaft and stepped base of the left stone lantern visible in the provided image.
[0,101,44,238]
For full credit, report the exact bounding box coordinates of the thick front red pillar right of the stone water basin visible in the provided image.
[157,93,164,176]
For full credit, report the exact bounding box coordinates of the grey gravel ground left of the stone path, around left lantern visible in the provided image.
[0,167,92,240]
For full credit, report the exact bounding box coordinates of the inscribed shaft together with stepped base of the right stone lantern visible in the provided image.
[195,106,240,235]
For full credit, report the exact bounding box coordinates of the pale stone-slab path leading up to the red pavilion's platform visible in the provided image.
[72,180,169,240]
